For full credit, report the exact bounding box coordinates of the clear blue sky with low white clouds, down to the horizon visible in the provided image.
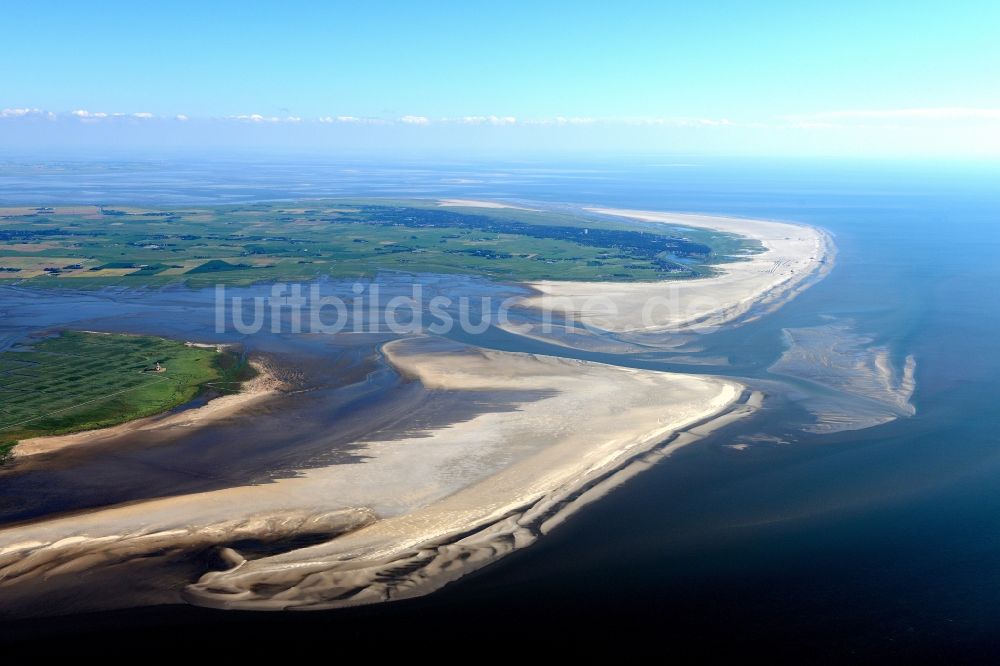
[0,0,1000,155]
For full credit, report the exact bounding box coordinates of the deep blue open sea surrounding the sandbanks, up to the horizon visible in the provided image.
[0,158,1000,661]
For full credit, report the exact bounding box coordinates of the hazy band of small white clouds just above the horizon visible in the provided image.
[0,107,1000,157]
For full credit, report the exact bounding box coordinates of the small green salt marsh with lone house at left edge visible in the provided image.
[0,331,253,459]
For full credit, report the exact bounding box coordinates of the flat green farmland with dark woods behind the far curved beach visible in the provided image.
[0,200,763,288]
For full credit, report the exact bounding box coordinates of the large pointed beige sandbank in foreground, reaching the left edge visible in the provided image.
[0,338,755,609]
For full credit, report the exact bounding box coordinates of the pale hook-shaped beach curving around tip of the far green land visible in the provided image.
[523,208,835,334]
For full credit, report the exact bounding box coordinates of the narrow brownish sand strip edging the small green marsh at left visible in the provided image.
[13,356,283,460]
